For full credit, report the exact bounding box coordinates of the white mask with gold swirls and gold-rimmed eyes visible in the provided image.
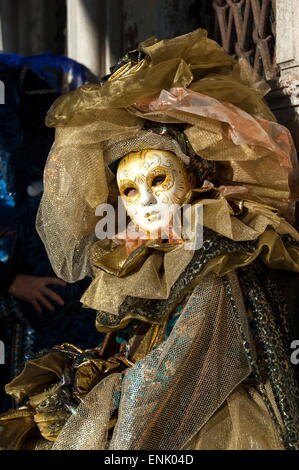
[117,150,190,233]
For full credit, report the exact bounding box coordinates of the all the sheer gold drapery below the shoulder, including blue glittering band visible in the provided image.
[46,273,283,450]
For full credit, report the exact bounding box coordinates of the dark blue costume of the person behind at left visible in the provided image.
[0,54,101,411]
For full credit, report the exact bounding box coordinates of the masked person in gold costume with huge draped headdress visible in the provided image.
[0,30,299,450]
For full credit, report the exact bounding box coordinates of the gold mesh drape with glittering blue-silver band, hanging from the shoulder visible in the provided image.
[110,275,254,449]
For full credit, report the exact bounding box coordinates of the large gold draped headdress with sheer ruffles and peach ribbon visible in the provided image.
[37,29,298,294]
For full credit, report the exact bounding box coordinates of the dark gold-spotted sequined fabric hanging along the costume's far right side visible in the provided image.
[239,262,299,449]
